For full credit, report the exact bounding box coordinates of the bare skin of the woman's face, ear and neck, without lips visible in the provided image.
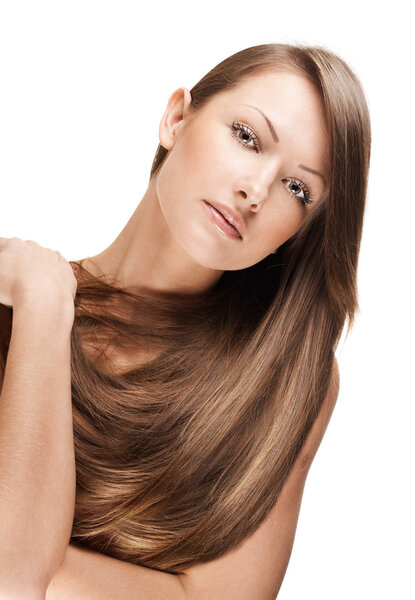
[83,72,329,295]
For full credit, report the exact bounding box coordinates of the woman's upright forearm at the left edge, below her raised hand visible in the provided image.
[0,297,75,597]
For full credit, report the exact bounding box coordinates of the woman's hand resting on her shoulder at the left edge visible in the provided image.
[0,237,78,307]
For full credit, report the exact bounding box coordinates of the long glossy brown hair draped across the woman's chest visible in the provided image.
[0,44,371,573]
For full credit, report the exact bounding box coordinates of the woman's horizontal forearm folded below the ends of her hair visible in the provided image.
[46,544,187,600]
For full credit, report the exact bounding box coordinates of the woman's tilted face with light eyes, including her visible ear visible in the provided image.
[155,72,329,270]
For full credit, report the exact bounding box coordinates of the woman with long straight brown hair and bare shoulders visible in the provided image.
[0,44,371,599]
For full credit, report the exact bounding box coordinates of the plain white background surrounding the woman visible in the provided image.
[0,0,415,600]
